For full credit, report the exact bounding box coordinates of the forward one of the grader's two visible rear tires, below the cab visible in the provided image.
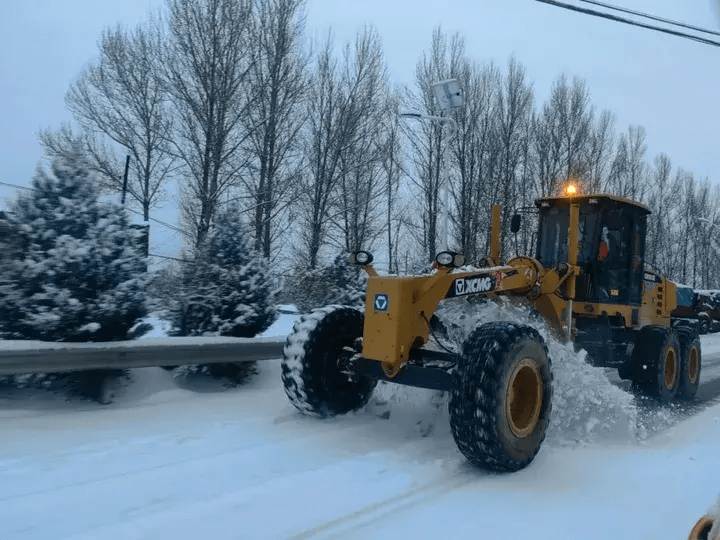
[632,326,682,403]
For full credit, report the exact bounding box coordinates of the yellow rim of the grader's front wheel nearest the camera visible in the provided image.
[505,358,543,439]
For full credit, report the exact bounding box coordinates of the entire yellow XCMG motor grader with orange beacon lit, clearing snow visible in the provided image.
[282,190,701,471]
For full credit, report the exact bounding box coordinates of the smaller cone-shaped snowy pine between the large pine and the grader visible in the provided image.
[173,204,277,337]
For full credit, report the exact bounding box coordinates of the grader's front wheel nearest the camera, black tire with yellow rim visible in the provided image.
[449,322,552,471]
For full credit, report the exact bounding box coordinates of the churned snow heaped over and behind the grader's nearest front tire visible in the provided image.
[437,298,638,446]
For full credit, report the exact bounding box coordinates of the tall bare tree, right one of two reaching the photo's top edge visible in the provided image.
[243,0,309,257]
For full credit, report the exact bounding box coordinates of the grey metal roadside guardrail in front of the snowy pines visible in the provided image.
[0,336,286,375]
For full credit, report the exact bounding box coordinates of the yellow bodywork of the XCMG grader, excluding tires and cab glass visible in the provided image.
[362,195,676,378]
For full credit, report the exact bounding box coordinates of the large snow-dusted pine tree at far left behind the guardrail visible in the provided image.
[0,149,146,342]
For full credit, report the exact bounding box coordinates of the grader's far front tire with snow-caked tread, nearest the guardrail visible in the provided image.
[282,306,377,417]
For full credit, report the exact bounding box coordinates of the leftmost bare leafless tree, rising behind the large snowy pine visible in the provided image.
[40,22,175,221]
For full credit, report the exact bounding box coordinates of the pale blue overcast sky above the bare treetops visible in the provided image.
[0,0,720,258]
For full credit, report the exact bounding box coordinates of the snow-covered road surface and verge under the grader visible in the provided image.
[0,316,720,540]
